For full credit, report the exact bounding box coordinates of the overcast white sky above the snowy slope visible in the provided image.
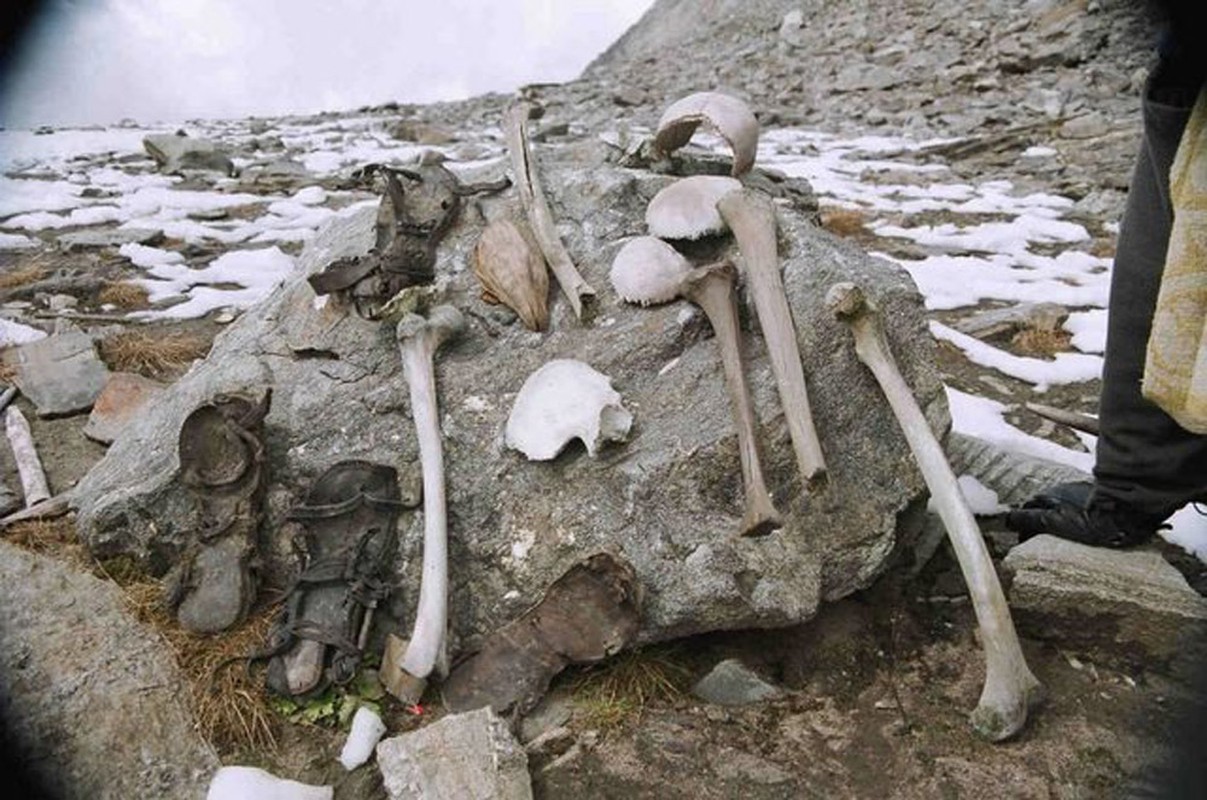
[0,0,653,127]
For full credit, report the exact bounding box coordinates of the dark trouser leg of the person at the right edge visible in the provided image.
[1094,79,1207,514]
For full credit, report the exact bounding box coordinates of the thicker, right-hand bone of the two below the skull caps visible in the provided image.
[717,188,826,487]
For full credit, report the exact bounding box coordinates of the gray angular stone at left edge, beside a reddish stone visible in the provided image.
[0,331,109,416]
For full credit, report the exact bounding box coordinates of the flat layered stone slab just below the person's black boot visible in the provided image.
[1003,536,1207,666]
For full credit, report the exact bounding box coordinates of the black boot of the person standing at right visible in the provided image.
[1005,481,1168,548]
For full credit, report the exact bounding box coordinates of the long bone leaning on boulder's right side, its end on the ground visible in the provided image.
[826,282,1044,742]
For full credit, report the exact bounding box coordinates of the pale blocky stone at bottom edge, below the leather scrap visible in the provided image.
[377,708,532,800]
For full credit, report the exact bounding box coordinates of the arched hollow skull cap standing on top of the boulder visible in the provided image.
[654,92,758,176]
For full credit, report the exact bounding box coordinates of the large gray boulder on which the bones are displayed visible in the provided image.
[75,139,949,652]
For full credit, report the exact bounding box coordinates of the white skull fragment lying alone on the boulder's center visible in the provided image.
[503,358,632,461]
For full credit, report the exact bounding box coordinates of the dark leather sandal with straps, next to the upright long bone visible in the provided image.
[256,461,407,697]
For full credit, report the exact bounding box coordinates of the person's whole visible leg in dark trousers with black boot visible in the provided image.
[1007,64,1207,547]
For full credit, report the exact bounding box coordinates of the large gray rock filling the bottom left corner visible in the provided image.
[0,542,218,800]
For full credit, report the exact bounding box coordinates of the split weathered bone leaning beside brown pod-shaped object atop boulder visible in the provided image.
[503,103,595,320]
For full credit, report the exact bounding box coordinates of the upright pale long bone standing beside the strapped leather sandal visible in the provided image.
[381,305,466,703]
